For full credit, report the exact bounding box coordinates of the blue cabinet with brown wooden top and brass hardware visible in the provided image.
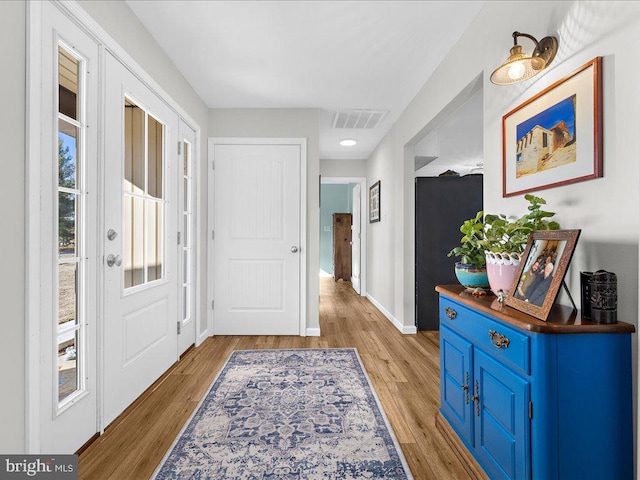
[436,286,635,480]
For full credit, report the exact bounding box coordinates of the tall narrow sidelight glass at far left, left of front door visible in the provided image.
[54,45,86,408]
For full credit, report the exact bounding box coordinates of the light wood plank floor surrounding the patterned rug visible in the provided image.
[79,278,469,480]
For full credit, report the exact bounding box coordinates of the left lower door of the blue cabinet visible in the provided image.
[440,325,473,447]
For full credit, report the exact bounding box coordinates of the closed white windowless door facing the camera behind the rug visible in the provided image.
[209,140,304,335]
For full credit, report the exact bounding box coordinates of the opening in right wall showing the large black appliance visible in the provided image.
[413,76,484,330]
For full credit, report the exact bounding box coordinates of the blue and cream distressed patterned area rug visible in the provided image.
[153,349,412,480]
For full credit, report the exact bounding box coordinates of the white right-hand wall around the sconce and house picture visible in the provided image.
[367,1,640,468]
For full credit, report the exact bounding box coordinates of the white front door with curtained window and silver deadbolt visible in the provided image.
[102,54,179,425]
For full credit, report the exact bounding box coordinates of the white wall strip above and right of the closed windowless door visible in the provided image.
[207,108,320,329]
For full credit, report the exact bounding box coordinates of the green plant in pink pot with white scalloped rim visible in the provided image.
[483,194,560,296]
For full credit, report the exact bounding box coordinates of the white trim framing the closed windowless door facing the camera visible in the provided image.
[207,137,307,337]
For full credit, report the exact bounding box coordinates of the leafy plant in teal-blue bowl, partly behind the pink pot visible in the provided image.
[448,211,489,289]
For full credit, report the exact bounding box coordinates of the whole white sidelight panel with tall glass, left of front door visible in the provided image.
[38,2,99,453]
